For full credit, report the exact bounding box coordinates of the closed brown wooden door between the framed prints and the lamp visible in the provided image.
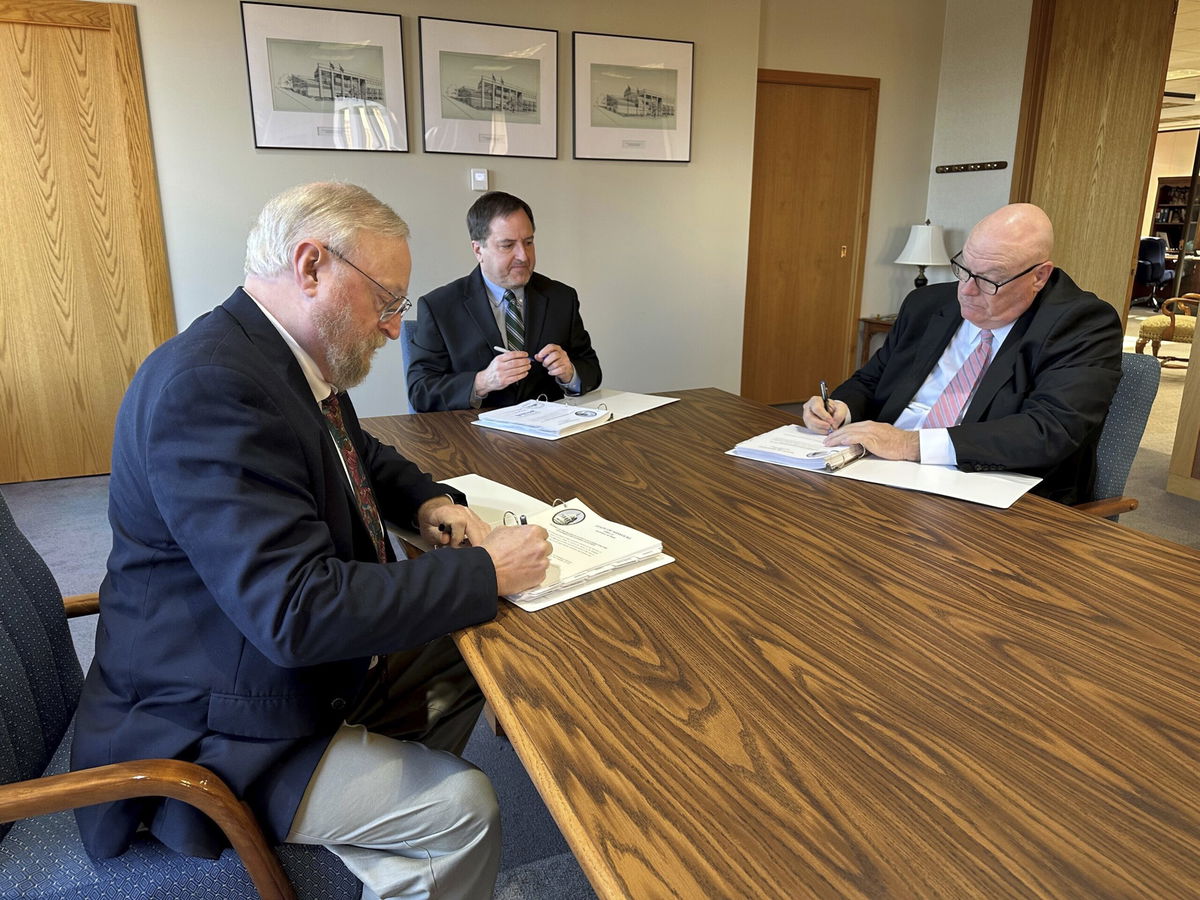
[742,70,880,403]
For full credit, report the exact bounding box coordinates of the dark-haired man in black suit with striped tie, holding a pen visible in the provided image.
[408,191,600,413]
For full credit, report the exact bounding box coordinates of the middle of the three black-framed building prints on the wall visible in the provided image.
[419,16,558,160]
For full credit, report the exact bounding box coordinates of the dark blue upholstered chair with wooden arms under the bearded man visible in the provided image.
[0,497,361,900]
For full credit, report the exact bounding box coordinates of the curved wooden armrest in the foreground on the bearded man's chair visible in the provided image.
[0,760,295,900]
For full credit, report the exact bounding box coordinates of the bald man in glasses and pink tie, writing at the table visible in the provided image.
[803,203,1122,504]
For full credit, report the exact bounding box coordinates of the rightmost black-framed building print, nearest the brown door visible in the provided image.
[572,31,695,162]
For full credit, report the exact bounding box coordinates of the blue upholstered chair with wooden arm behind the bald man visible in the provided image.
[1075,353,1160,522]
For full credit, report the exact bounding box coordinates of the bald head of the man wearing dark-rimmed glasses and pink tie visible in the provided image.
[959,203,1054,329]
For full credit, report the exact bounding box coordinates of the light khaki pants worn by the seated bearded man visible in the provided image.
[286,637,500,900]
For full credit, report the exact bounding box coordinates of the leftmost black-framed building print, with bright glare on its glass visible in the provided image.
[241,0,408,152]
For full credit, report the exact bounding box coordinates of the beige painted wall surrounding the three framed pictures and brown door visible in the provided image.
[117,0,1028,415]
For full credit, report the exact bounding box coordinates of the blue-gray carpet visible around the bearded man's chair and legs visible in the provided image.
[0,476,595,900]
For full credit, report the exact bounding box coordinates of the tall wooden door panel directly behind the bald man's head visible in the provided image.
[1012,0,1175,312]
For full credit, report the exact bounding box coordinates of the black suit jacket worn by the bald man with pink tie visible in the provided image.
[832,269,1123,503]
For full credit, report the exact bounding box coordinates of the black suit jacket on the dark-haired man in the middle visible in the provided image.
[408,265,600,413]
